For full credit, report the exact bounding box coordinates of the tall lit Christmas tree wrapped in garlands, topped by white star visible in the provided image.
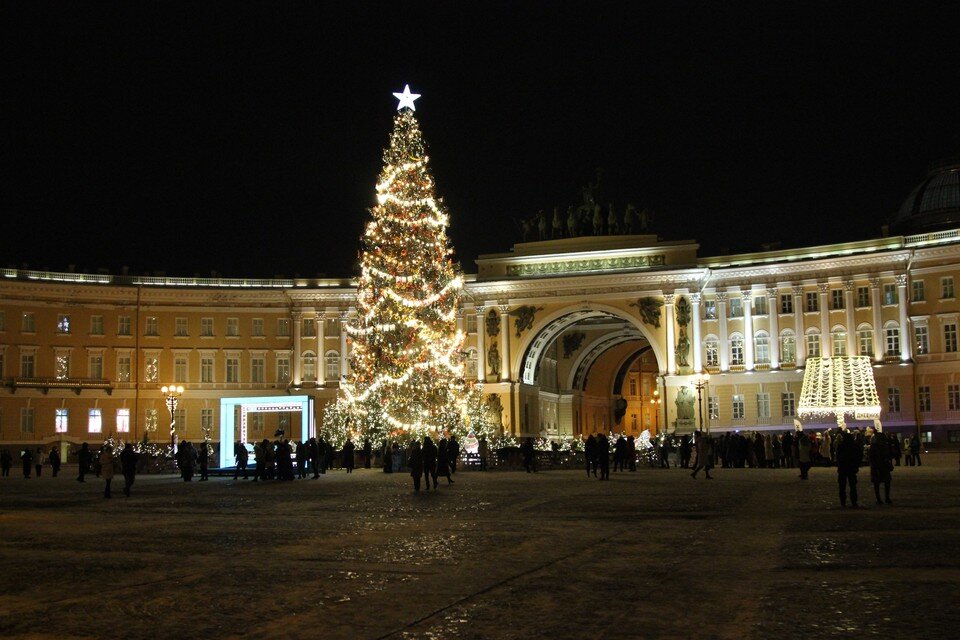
[324,85,471,443]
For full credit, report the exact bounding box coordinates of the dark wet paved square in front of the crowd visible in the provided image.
[0,452,960,639]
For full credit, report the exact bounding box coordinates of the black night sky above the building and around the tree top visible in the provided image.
[0,0,960,277]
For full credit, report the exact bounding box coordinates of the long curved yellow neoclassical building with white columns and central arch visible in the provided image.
[0,163,960,456]
